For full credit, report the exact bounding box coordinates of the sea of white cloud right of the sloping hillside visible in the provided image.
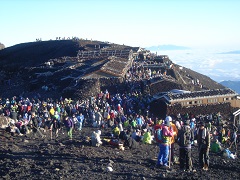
[158,49,240,82]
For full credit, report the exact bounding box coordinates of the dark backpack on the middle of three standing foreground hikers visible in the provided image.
[178,126,192,146]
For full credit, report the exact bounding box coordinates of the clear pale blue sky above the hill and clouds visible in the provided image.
[0,0,240,50]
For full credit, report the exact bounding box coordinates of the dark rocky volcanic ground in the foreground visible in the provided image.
[0,127,240,180]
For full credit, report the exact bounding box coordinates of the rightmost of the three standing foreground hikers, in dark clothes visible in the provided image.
[197,122,210,171]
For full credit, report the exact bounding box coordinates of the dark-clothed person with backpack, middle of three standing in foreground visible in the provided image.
[178,120,194,171]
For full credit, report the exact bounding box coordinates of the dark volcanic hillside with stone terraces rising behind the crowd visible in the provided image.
[0,39,224,98]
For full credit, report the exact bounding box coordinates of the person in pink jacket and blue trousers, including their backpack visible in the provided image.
[154,119,173,168]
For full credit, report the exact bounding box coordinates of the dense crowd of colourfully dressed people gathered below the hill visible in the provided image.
[0,90,237,171]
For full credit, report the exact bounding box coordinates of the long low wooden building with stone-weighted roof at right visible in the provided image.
[150,88,240,118]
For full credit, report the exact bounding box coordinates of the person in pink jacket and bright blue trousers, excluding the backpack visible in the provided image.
[157,119,173,168]
